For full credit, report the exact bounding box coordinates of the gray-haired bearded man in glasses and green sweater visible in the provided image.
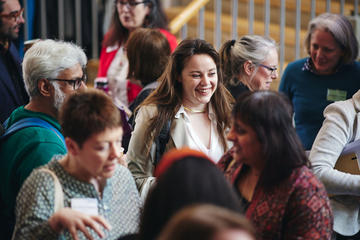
[0,40,87,239]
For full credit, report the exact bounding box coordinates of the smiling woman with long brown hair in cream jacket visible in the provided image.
[127,39,233,198]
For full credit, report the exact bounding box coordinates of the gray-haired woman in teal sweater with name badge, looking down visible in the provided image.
[279,13,360,150]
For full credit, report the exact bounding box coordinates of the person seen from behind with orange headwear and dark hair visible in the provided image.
[138,148,242,240]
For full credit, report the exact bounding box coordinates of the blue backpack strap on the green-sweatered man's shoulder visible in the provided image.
[0,117,66,146]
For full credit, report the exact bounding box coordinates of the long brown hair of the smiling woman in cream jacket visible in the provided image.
[139,39,234,154]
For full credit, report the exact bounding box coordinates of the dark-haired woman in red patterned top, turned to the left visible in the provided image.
[219,91,333,239]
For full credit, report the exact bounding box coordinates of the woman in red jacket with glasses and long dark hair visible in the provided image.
[98,0,177,107]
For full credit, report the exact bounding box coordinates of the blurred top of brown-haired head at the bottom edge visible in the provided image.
[157,204,256,240]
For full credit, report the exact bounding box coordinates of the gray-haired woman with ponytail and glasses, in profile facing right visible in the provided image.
[220,35,278,98]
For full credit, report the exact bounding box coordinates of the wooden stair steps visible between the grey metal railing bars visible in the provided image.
[166,0,354,90]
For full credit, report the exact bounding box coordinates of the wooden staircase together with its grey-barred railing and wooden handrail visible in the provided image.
[168,0,360,77]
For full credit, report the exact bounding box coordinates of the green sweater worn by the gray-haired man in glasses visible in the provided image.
[0,106,67,239]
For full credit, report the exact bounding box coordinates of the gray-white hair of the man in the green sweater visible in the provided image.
[22,39,87,98]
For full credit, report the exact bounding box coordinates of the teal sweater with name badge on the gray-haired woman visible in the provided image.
[279,58,360,150]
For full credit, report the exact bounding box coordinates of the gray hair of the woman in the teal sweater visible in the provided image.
[305,13,359,64]
